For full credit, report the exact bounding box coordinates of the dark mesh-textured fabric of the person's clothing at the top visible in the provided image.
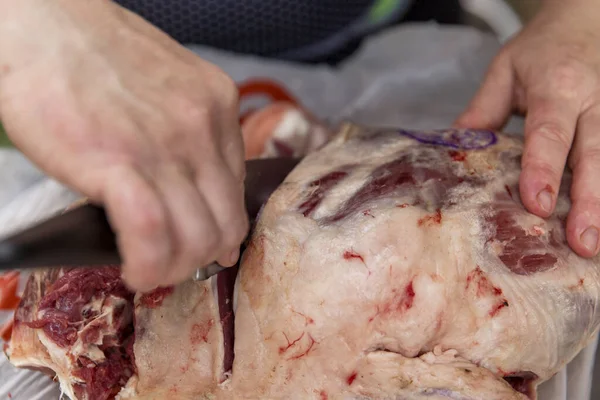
[117,0,373,56]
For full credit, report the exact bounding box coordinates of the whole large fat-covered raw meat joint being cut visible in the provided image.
[8,125,600,400]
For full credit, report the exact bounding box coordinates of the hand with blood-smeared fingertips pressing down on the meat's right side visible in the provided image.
[456,0,600,257]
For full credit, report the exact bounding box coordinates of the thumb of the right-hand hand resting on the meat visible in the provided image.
[454,55,515,129]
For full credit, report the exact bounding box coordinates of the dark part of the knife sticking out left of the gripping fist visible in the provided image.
[0,204,121,271]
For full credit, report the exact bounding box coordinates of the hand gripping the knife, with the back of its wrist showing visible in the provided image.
[0,0,248,291]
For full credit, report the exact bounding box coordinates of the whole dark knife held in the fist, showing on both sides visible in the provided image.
[0,158,300,280]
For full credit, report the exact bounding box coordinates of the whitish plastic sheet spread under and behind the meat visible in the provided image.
[0,23,596,400]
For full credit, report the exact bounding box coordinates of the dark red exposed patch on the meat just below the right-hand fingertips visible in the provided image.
[486,209,558,275]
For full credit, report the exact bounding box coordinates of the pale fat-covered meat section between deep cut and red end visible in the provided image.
[122,279,225,398]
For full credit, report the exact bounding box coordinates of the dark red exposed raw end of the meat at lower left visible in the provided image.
[9,267,135,400]
